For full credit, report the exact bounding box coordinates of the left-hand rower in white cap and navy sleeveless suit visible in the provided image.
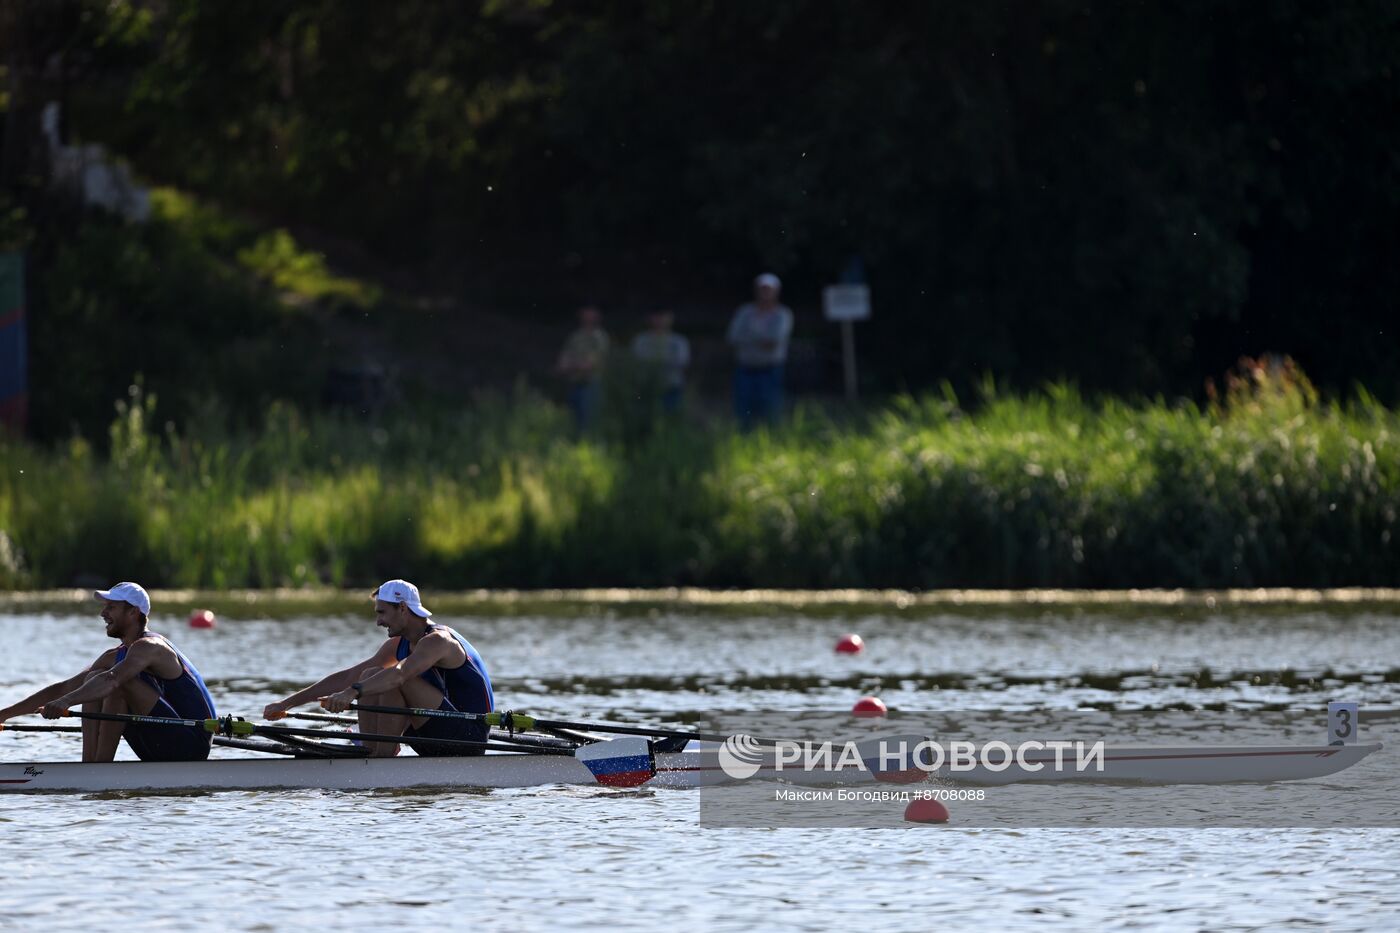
[0,583,216,762]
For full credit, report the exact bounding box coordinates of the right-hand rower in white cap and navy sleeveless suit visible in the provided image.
[263,580,496,758]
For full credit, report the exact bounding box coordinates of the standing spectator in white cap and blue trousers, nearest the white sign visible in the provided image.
[725,272,792,431]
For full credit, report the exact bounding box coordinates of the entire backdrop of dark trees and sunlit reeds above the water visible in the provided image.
[0,0,1400,587]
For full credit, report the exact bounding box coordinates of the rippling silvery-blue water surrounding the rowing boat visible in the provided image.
[0,600,1400,930]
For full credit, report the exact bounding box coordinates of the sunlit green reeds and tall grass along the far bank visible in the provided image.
[0,360,1400,588]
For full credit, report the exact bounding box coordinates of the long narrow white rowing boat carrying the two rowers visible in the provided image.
[0,742,1380,793]
